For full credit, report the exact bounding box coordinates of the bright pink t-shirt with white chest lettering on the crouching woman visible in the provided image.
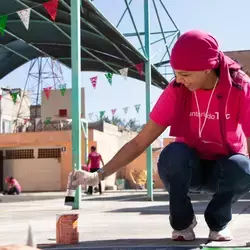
[150,80,250,159]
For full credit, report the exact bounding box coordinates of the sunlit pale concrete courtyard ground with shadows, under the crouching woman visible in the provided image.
[0,191,250,249]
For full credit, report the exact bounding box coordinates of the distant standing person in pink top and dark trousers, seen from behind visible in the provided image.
[87,146,104,194]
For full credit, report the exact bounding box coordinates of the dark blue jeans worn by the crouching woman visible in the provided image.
[158,142,250,231]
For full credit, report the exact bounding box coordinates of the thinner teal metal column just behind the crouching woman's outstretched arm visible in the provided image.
[144,0,154,201]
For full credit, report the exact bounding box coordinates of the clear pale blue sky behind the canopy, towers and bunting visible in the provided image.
[0,0,250,138]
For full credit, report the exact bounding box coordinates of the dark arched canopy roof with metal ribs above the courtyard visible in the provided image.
[0,0,168,88]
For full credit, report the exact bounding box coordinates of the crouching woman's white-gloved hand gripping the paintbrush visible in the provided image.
[70,170,100,187]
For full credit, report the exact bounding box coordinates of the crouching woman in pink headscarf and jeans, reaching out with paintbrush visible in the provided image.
[69,30,250,241]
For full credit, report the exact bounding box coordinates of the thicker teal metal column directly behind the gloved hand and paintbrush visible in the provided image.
[71,0,82,209]
